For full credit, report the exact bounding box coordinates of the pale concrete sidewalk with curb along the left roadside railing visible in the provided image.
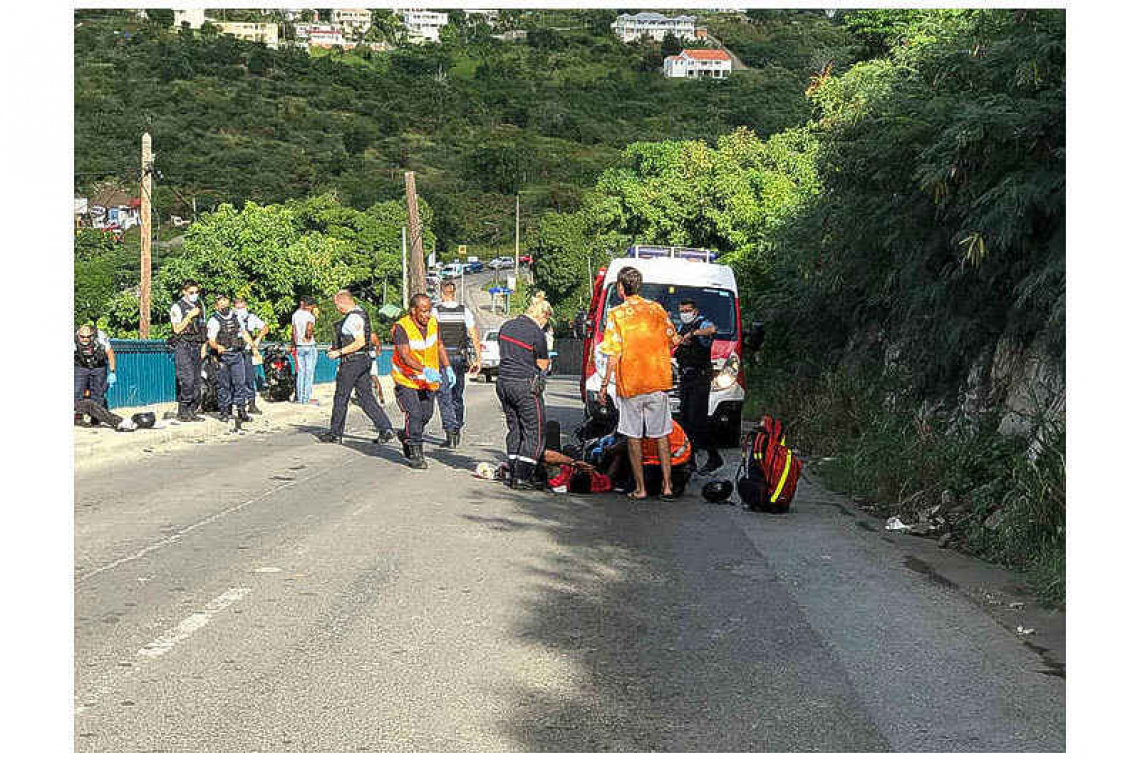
[72,383,342,472]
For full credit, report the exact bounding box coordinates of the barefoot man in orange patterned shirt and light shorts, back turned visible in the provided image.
[597,267,676,501]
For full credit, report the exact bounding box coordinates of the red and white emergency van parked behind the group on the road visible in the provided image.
[580,245,744,439]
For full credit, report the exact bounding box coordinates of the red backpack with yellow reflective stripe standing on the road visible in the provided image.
[736,415,804,512]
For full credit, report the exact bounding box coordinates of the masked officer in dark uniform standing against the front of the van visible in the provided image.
[673,299,724,475]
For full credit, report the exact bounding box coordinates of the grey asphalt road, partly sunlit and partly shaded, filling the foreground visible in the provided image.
[75,381,1065,752]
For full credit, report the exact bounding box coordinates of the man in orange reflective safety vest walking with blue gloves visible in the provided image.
[392,293,455,469]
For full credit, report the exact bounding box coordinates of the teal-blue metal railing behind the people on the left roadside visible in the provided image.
[107,340,392,409]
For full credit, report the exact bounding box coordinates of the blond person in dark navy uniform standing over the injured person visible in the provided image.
[495,291,553,491]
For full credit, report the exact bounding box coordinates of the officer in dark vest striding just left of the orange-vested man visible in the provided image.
[317,291,393,443]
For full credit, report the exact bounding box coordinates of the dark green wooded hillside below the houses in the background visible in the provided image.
[75,10,839,248]
